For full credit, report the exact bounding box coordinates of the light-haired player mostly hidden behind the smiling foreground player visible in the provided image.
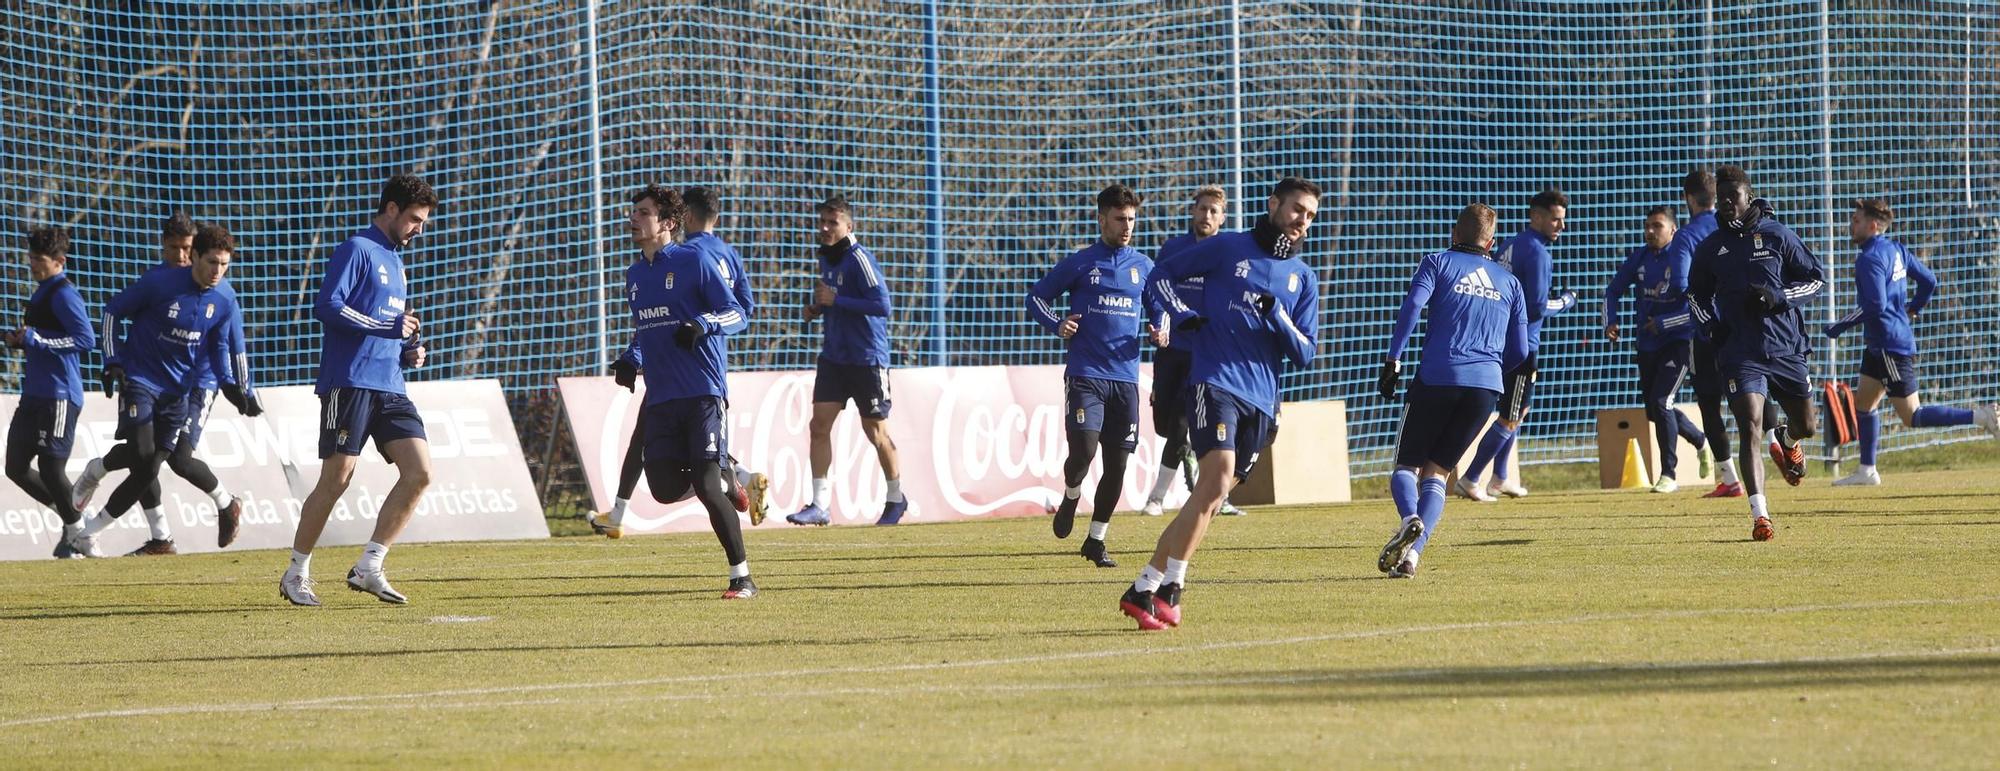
[1140,184,1244,517]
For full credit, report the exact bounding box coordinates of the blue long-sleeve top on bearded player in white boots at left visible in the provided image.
[312,226,410,395]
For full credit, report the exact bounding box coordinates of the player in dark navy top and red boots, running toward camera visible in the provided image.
[1688,166,1826,541]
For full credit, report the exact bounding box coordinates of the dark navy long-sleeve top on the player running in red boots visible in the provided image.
[1688,198,1826,362]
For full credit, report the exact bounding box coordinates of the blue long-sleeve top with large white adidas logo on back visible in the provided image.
[1388,250,1530,391]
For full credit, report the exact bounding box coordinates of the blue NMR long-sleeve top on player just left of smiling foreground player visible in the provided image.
[1028,240,1152,384]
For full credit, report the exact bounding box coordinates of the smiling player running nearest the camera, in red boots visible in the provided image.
[1118,178,1320,629]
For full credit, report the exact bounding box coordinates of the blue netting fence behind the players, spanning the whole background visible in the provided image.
[0,0,2000,493]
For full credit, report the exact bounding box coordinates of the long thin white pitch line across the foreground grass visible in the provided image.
[0,595,2000,729]
